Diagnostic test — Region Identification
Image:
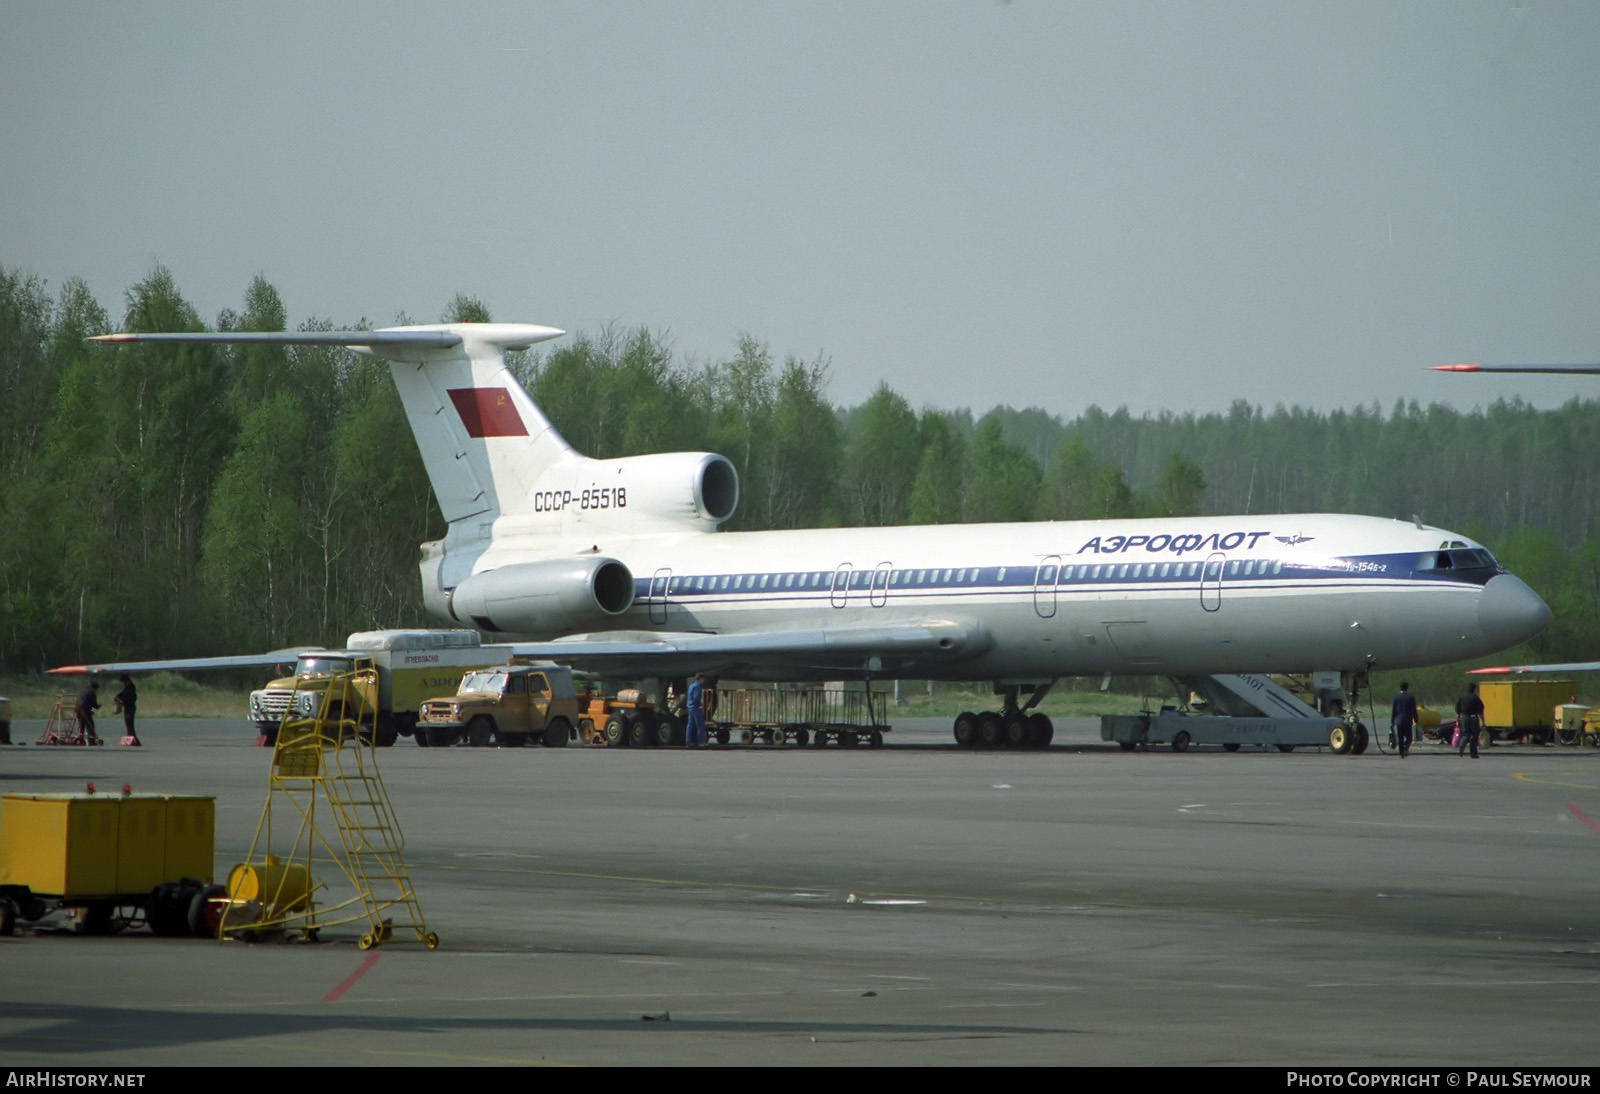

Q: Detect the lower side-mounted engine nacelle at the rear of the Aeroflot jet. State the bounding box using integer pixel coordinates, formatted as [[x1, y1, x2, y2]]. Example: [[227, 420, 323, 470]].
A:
[[445, 557, 634, 638]]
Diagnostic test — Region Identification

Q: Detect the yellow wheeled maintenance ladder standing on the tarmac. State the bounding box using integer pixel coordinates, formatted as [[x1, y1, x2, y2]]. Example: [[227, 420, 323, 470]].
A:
[[219, 669, 438, 950]]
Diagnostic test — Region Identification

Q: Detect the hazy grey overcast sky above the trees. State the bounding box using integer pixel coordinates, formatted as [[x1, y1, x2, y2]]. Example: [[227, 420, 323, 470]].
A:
[[0, 0, 1600, 417]]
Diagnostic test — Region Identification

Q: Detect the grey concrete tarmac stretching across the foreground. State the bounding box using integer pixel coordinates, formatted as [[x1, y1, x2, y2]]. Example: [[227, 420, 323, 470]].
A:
[[0, 720, 1600, 1068]]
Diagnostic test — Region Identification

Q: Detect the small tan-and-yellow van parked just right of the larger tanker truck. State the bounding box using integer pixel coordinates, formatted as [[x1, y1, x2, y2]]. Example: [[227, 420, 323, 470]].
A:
[[416, 664, 578, 749]]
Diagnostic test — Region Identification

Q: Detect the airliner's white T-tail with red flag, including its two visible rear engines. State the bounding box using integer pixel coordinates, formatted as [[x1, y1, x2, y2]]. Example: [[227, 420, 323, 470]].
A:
[[94, 323, 739, 632]]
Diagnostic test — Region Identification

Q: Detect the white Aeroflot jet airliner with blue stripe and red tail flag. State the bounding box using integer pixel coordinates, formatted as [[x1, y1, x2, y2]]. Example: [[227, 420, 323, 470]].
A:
[[59, 323, 1550, 742]]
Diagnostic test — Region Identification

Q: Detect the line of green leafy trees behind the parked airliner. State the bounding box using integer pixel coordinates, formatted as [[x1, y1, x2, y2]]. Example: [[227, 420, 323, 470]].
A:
[[0, 267, 1600, 672]]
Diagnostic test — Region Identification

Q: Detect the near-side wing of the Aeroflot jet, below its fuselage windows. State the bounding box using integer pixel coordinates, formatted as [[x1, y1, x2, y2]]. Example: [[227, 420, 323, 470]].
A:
[[510, 619, 990, 678]]
